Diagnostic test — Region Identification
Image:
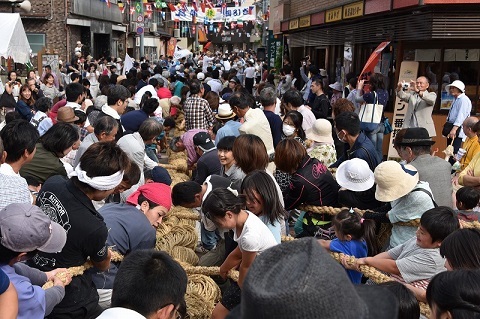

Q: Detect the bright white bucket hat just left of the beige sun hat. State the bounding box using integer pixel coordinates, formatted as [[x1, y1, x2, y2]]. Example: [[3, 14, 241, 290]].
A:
[[335, 158, 375, 192]]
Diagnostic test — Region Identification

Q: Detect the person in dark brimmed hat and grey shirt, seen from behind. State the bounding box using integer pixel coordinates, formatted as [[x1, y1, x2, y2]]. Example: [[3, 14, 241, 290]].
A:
[[394, 127, 452, 207]]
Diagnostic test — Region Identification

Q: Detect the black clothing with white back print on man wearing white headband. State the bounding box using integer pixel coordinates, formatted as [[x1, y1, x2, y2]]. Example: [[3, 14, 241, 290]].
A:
[[29, 175, 108, 317]]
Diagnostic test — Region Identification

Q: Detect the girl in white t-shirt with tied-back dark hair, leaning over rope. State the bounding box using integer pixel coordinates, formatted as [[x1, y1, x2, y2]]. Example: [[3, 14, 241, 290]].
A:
[[202, 188, 277, 319]]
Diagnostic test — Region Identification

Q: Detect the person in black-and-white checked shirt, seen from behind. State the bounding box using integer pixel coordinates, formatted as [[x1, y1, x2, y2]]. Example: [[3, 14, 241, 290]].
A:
[[183, 80, 215, 131]]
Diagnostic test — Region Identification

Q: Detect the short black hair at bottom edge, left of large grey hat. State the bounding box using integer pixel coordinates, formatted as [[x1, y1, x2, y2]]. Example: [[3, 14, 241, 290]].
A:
[[112, 249, 187, 317]]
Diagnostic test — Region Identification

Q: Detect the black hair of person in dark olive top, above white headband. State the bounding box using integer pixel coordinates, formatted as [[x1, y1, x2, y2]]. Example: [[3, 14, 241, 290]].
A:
[[40, 122, 80, 155]]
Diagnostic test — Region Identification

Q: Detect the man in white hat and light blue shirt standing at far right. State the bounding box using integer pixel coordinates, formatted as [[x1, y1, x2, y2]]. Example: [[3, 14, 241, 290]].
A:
[[442, 80, 472, 153]]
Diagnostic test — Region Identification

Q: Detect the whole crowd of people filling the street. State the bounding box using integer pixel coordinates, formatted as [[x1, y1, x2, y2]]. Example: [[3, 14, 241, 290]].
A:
[[0, 47, 480, 319]]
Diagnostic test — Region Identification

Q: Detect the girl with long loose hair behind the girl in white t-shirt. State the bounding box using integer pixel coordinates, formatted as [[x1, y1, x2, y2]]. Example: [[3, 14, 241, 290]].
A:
[[242, 171, 286, 244]]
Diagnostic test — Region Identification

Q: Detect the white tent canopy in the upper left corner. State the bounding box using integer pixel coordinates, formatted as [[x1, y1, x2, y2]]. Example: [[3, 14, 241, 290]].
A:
[[0, 13, 32, 63]]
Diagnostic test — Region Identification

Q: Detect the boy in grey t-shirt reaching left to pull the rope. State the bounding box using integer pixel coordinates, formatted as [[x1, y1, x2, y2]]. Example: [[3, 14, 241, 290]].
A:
[[344, 206, 460, 289]]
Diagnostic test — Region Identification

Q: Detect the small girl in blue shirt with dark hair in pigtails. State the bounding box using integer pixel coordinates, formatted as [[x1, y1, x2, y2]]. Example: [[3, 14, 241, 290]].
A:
[[319, 209, 378, 284]]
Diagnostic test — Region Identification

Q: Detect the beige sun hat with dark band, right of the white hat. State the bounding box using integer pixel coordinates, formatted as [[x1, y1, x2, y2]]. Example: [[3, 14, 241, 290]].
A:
[[374, 161, 419, 203]]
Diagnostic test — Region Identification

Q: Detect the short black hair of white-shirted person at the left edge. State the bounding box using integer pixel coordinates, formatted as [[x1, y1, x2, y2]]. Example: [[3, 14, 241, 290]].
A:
[[0, 120, 39, 163]]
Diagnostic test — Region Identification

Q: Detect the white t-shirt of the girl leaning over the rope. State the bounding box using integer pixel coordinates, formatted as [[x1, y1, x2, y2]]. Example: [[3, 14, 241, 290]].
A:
[[233, 210, 277, 254]]
